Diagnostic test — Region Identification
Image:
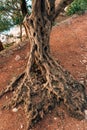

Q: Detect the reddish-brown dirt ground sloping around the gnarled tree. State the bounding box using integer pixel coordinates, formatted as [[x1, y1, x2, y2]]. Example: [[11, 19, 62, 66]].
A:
[[0, 14, 87, 130]]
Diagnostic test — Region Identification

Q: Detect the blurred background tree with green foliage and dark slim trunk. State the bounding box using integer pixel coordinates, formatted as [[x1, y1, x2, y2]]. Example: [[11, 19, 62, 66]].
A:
[[0, 0, 30, 39]]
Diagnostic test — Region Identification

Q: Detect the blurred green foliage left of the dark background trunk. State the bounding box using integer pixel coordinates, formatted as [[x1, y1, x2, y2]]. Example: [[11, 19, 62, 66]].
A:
[[0, 0, 22, 32]]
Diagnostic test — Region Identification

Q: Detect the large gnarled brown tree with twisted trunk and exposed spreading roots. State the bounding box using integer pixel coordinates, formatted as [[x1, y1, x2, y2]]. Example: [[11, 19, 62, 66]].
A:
[[0, 0, 87, 128]]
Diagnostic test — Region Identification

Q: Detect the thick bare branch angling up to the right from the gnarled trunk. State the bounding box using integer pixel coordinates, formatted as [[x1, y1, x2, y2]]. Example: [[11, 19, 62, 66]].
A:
[[54, 0, 73, 19]]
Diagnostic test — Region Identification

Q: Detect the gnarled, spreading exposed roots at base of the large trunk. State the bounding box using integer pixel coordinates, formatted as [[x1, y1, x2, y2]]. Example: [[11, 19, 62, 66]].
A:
[[0, 55, 87, 129]]
